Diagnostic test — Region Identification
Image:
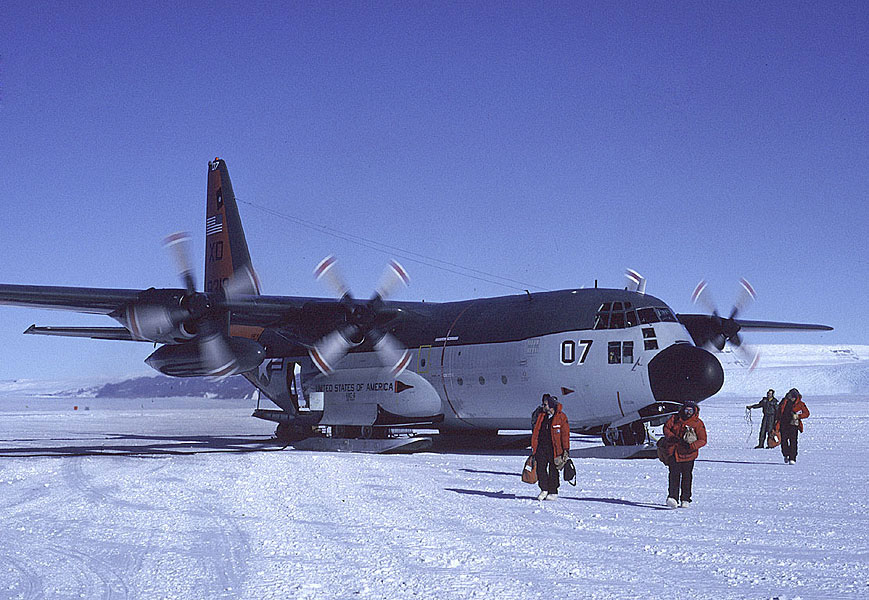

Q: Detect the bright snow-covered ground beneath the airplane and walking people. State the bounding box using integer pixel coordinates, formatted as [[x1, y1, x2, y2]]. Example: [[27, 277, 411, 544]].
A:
[[0, 392, 869, 600]]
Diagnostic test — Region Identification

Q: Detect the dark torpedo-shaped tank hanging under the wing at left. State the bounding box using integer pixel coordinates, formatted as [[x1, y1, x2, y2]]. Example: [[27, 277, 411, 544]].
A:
[[145, 337, 266, 377]]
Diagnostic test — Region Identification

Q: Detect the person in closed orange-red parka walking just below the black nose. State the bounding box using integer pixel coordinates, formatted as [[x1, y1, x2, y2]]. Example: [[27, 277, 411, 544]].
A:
[[664, 402, 706, 508]]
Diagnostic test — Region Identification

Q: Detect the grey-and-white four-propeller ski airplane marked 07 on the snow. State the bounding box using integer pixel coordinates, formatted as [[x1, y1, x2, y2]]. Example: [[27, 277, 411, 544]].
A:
[[0, 158, 832, 448]]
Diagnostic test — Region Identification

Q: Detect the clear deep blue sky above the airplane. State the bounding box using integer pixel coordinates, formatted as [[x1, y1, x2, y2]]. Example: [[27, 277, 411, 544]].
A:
[[0, 0, 869, 379]]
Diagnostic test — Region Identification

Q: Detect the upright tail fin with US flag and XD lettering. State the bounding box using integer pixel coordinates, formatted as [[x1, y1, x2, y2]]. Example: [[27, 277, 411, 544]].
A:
[[205, 158, 260, 295]]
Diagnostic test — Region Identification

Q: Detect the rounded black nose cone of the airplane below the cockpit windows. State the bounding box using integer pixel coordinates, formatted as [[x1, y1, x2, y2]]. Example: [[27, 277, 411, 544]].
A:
[[649, 344, 724, 402]]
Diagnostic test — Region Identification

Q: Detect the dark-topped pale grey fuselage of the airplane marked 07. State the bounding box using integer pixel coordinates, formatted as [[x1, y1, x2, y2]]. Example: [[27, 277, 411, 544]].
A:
[[241, 289, 723, 430]]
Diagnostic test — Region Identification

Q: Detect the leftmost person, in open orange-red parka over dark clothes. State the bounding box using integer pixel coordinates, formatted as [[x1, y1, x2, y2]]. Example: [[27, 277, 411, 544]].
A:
[[531, 396, 570, 500]]
